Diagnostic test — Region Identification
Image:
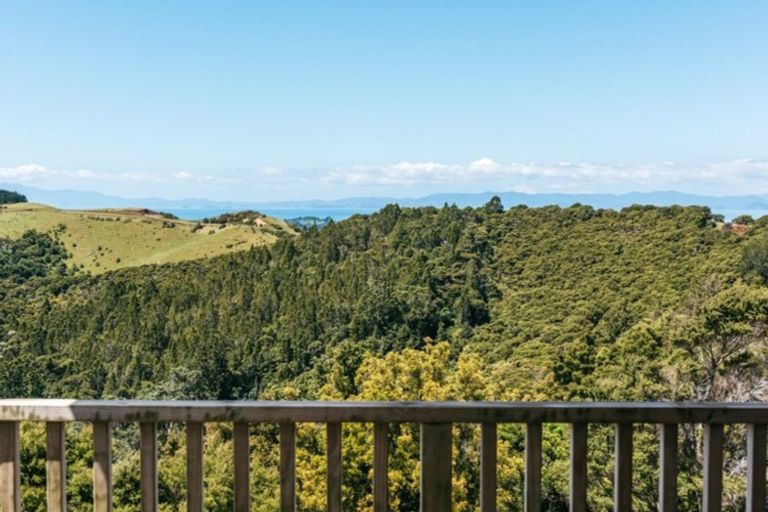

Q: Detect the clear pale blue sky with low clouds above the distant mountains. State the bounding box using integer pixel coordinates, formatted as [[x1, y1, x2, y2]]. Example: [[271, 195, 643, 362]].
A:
[[0, 0, 768, 200]]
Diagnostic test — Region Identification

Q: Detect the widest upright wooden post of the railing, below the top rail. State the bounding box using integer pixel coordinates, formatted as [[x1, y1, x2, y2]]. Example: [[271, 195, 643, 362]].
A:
[[421, 423, 452, 512]]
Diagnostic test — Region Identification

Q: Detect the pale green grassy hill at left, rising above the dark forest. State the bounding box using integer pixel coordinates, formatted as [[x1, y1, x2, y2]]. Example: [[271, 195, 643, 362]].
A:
[[0, 203, 294, 274]]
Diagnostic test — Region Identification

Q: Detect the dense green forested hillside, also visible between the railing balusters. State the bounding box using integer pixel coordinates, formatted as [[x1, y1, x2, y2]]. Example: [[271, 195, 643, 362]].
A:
[[0, 200, 768, 510]]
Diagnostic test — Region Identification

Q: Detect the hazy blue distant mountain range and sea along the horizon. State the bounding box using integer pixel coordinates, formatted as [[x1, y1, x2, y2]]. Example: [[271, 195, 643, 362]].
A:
[[0, 184, 768, 218]]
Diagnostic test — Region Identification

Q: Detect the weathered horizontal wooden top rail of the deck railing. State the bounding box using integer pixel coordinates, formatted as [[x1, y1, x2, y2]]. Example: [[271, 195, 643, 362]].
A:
[[0, 399, 768, 423]]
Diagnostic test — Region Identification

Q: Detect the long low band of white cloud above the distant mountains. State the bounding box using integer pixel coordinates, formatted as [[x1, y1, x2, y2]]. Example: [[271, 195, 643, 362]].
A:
[[0, 157, 768, 200]]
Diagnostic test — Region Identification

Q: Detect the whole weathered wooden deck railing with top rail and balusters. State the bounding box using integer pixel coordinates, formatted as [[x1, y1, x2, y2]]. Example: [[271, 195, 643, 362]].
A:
[[0, 400, 768, 512]]
